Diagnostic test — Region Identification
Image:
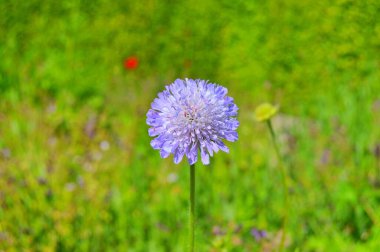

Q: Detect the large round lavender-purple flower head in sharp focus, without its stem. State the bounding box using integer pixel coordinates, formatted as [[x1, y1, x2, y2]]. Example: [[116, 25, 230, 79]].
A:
[[146, 79, 239, 164]]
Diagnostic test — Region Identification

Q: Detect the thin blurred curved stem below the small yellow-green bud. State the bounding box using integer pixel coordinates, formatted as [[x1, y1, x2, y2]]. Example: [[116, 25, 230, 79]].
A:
[[267, 120, 289, 251]]
